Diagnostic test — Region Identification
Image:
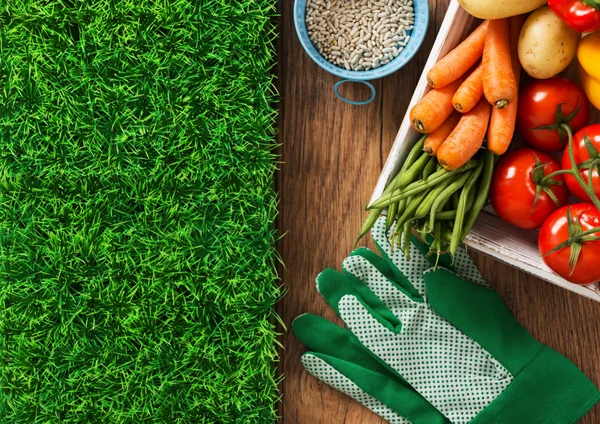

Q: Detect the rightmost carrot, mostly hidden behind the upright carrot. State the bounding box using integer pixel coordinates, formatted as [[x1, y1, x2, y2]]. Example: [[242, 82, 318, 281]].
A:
[[487, 15, 525, 155]]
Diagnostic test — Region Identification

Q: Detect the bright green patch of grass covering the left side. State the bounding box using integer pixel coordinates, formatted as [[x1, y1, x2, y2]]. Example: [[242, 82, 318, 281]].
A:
[[0, 0, 280, 424]]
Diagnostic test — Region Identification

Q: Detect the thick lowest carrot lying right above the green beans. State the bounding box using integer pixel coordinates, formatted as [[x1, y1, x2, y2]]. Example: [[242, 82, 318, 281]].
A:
[[437, 98, 492, 170]]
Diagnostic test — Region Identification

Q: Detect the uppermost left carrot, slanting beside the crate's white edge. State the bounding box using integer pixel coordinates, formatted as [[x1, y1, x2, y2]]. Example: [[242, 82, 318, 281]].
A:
[[427, 21, 488, 88]]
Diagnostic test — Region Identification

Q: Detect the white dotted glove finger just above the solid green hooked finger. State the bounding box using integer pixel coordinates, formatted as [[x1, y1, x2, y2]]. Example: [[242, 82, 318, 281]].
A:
[[342, 255, 423, 312]]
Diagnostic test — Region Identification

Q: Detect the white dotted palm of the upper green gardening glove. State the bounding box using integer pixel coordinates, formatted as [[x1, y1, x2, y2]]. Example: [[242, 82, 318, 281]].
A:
[[338, 294, 513, 424]]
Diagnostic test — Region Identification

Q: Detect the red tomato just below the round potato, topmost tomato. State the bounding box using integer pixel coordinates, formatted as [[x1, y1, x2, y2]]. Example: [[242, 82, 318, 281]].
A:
[[517, 77, 590, 152]]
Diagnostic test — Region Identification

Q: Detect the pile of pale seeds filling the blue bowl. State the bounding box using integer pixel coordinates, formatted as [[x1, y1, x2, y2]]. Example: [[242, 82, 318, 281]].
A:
[[306, 0, 415, 71]]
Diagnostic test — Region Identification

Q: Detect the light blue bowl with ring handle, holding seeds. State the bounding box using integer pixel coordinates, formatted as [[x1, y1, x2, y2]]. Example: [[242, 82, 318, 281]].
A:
[[294, 0, 429, 105]]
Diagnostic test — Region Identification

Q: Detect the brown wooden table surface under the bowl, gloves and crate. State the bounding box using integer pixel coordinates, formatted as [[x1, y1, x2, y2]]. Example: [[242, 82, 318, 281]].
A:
[[277, 0, 600, 424]]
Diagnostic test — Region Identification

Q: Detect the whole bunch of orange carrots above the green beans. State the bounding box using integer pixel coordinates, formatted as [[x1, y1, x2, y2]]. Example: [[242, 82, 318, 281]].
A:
[[410, 15, 525, 170]]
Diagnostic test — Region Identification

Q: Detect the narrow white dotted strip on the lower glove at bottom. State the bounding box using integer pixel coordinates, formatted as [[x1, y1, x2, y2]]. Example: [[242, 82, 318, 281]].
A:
[[302, 353, 411, 424]]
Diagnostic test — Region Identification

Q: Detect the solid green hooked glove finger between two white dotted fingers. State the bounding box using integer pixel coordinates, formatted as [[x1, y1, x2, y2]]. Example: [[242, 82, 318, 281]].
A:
[[317, 268, 406, 332]]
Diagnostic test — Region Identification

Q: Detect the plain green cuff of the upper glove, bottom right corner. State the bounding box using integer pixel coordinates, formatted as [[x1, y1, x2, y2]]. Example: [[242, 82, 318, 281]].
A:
[[470, 346, 600, 424]]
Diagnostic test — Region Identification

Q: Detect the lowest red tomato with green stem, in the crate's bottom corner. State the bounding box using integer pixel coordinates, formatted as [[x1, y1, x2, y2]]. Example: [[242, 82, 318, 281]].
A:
[[538, 203, 600, 284]]
